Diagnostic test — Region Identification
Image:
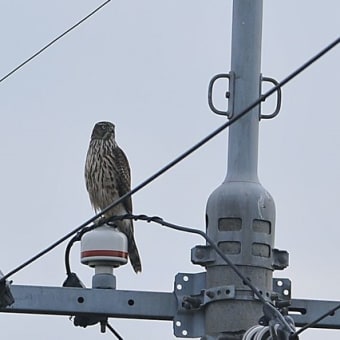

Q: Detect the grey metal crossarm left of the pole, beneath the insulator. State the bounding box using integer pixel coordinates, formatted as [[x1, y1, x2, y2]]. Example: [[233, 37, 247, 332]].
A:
[[0, 285, 177, 320]]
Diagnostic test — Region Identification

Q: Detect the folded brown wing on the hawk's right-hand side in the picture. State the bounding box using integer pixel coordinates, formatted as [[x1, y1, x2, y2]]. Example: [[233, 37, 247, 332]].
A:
[[113, 146, 132, 213]]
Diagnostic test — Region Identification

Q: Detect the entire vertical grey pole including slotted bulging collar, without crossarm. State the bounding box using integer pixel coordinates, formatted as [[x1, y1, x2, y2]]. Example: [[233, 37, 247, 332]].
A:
[[205, 0, 275, 340]]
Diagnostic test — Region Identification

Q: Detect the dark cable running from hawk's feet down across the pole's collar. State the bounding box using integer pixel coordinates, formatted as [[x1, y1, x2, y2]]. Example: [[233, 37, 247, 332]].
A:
[[110, 214, 295, 334]]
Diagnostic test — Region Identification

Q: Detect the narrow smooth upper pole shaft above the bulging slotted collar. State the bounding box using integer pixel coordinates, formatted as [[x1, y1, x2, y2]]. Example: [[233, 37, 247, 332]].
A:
[[227, 0, 262, 182]]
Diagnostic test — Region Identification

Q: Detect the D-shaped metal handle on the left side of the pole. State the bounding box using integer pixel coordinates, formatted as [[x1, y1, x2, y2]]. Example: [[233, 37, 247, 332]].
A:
[[208, 72, 235, 118]]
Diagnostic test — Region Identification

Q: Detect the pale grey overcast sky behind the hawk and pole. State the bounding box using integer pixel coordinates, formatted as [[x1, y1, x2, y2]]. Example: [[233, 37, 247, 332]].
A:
[[0, 0, 340, 340]]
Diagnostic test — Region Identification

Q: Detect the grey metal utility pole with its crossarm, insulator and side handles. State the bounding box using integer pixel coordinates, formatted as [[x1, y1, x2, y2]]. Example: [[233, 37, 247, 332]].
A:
[[0, 0, 340, 340]]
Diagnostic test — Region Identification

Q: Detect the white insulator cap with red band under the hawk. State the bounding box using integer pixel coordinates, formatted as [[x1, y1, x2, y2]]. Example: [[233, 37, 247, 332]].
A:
[[80, 225, 128, 267]]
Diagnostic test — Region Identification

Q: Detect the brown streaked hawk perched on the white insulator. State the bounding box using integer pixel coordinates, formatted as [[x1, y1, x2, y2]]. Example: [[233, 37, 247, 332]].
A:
[[85, 122, 142, 273]]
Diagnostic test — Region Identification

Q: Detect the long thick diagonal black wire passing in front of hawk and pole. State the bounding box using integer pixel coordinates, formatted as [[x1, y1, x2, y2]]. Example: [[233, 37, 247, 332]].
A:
[[0, 37, 340, 282]]
